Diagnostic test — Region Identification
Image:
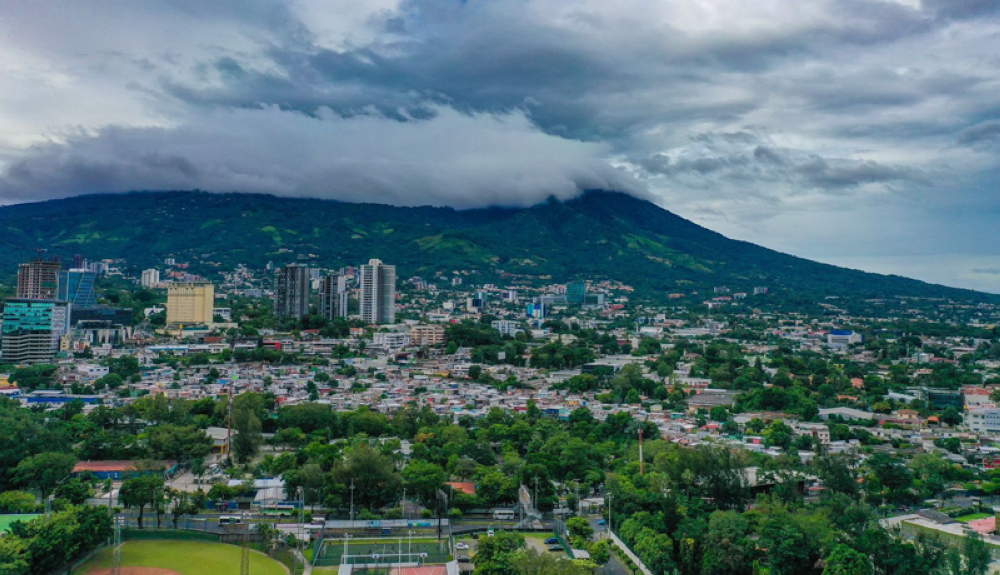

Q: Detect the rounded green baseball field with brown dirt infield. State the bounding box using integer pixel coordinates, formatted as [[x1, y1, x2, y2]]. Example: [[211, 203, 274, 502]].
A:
[[74, 540, 288, 575]]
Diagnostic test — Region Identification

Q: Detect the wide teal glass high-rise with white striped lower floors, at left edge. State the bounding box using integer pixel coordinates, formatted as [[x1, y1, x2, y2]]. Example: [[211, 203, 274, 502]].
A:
[[0, 298, 70, 365]]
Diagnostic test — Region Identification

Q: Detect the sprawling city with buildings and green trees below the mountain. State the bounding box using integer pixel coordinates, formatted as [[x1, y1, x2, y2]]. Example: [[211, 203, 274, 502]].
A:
[[0, 252, 1000, 575]]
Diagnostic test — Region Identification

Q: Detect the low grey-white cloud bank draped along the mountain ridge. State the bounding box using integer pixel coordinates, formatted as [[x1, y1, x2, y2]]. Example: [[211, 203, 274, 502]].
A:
[[0, 106, 634, 208]]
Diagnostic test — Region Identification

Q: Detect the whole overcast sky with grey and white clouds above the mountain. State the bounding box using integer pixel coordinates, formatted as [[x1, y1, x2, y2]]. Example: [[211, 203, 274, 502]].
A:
[[0, 0, 1000, 292]]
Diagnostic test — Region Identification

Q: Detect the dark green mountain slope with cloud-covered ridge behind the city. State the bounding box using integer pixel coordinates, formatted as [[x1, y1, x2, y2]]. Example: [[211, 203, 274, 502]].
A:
[[0, 191, 997, 301]]
